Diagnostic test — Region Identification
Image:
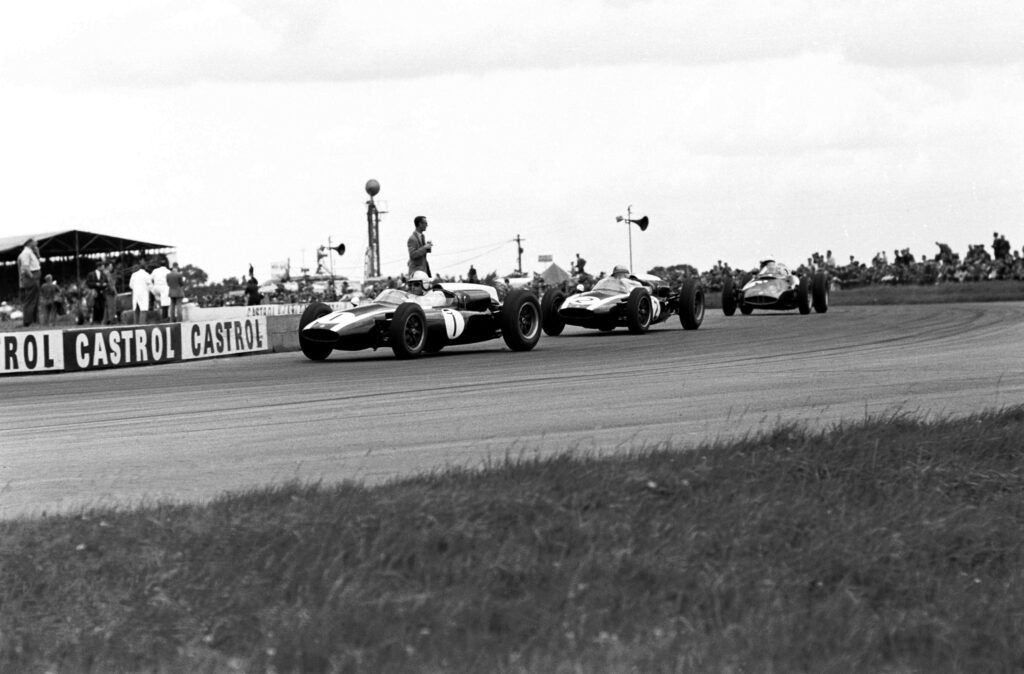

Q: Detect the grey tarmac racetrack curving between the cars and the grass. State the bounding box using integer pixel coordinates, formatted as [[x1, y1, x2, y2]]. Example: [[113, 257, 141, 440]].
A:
[[0, 302, 1024, 517]]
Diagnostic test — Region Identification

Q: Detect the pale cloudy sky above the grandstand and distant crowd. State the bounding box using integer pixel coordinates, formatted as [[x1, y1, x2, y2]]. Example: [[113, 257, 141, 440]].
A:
[[0, 0, 1024, 280]]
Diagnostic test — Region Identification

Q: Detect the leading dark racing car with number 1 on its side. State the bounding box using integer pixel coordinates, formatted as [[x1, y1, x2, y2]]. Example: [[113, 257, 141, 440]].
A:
[[299, 283, 541, 361]]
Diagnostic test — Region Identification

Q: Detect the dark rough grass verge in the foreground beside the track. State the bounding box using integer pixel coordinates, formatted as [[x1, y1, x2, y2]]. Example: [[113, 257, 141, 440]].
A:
[[0, 408, 1024, 672]]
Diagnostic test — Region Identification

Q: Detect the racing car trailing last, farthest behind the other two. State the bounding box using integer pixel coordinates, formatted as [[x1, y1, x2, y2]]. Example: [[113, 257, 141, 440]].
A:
[[722, 260, 828, 315]]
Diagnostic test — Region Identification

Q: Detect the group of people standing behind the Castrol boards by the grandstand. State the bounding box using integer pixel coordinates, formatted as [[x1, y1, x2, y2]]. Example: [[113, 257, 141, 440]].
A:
[[17, 239, 185, 327]]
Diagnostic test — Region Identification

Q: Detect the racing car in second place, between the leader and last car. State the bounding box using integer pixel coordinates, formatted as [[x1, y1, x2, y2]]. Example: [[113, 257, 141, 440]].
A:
[[541, 267, 705, 336]]
